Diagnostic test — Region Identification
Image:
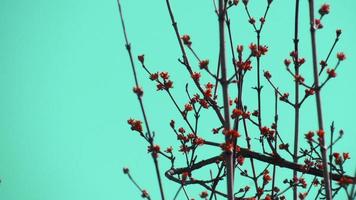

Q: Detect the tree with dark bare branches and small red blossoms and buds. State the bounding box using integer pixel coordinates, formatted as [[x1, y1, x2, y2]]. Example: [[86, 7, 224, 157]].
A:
[[118, 0, 356, 200]]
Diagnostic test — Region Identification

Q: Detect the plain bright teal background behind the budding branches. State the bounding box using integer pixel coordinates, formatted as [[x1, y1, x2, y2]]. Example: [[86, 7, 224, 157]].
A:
[[0, 0, 356, 200]]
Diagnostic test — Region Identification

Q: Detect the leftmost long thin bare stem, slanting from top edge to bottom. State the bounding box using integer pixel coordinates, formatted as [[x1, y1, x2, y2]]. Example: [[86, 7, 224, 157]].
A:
[[117, 0, 165, 200]]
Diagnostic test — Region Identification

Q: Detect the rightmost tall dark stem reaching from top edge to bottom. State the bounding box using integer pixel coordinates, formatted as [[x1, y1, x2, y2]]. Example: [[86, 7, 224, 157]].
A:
[[309, 0, 332, 200]]
